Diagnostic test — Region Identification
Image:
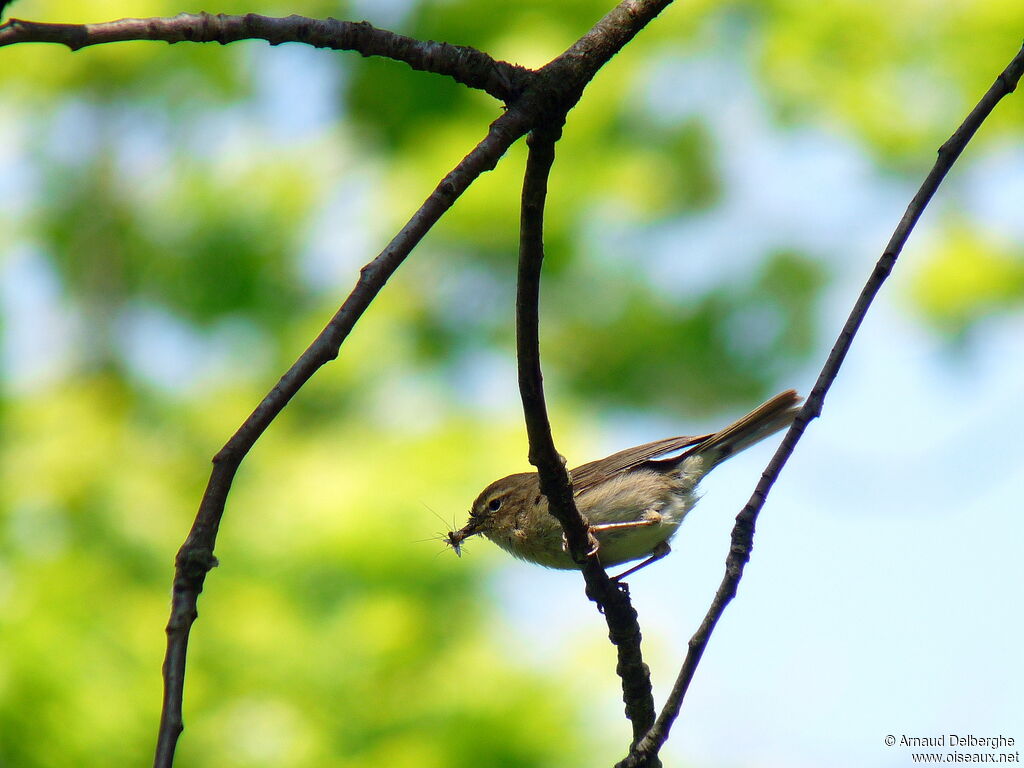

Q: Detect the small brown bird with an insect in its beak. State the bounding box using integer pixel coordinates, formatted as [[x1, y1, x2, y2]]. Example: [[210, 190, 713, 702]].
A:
[[446, 389, 801, 579]]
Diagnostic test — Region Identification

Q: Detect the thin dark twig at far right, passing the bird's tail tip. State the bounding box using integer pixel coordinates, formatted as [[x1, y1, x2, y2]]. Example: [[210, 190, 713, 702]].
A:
[[617, 40, 1024, 768]]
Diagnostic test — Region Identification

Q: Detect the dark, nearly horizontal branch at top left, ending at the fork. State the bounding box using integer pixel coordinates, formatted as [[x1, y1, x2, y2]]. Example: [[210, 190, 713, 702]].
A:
[[0, 12, 531, 101]]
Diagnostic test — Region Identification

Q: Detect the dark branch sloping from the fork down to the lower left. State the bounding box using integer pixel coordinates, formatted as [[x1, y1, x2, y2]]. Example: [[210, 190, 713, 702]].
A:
[[154, 110, 527, 768]]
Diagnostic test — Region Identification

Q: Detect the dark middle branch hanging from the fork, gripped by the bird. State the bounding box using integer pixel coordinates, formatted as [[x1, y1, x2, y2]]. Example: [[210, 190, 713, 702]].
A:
[[516, 120, 656, 760]]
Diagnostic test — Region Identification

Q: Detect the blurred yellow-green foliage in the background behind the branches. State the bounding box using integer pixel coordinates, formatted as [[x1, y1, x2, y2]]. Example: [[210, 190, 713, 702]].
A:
[[0, 0, 1024, 768]]
